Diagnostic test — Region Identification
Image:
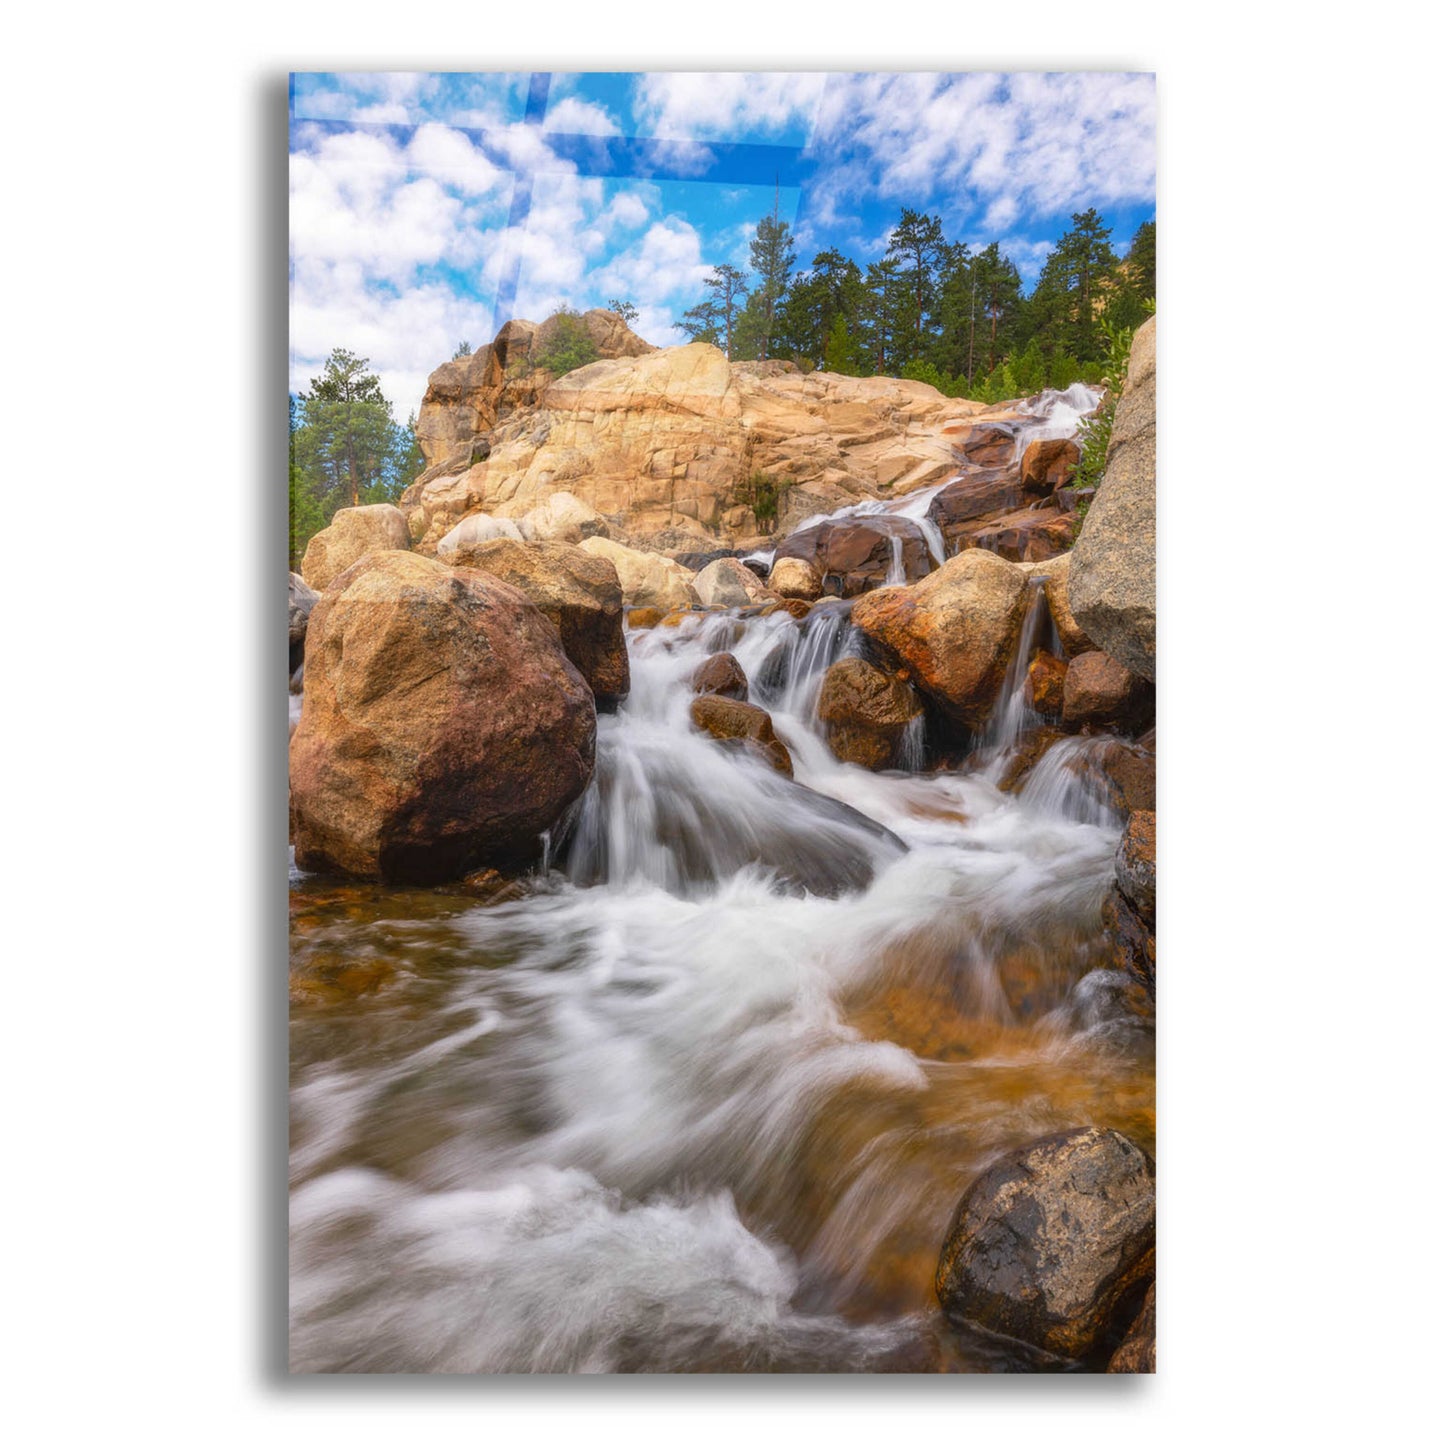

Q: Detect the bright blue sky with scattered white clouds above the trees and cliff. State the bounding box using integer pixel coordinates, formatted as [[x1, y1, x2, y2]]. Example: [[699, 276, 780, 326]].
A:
[[290, 71, 1155, 419]]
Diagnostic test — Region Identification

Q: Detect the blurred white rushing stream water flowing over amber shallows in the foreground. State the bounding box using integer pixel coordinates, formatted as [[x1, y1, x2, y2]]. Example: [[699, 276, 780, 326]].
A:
[[290, 603, 1153, 1371]]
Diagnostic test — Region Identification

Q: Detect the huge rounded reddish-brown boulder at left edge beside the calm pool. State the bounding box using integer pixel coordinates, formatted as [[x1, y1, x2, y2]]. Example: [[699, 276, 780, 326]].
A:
[[290, 552, 597, 883]]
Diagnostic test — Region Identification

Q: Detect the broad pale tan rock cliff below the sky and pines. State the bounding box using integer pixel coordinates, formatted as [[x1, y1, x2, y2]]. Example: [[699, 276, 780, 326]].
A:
[[400, 312, 985, 549]]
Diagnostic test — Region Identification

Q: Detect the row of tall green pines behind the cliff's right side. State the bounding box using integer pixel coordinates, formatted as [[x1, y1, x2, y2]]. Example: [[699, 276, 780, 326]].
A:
[[664, 207, 1155, 400]]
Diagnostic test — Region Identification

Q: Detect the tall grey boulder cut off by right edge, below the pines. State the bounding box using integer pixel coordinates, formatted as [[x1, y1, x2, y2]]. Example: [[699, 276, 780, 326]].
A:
[[1069, 316, 1156, 682]]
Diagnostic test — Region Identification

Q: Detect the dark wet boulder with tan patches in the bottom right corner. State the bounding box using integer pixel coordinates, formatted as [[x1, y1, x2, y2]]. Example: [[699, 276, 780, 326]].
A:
[[935, 1129, 1155, 1360]]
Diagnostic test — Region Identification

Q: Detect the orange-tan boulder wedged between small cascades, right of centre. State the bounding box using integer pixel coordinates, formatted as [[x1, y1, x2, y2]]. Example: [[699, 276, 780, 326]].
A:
[[853, 549, 1026, 728]]
